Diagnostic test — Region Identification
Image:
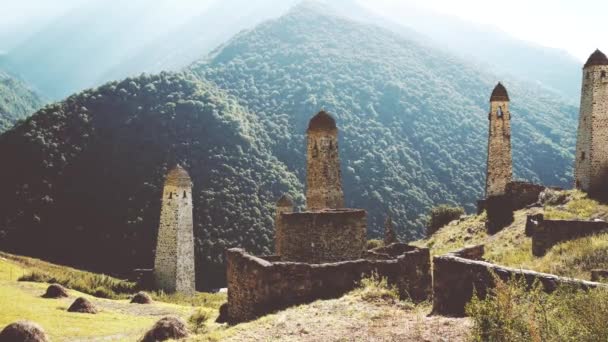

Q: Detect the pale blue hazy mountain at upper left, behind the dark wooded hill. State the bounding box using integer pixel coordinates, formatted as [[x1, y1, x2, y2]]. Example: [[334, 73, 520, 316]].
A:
[[0, 0, 296, 100]]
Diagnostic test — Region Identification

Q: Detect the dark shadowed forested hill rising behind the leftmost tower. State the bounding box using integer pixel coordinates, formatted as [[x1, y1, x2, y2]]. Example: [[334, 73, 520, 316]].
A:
[[0, 73, 302, 286]]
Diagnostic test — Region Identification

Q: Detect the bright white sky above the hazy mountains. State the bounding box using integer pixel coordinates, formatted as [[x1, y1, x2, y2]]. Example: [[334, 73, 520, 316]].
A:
[[0, 0, 608, 61]]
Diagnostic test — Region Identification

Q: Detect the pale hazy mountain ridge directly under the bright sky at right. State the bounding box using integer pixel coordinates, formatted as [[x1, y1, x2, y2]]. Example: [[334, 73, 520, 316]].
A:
[[354, 0, 580, 105]]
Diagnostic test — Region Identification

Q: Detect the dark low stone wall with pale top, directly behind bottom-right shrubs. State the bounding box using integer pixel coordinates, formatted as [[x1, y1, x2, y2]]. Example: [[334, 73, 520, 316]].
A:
[[433, 247, 604, 317]]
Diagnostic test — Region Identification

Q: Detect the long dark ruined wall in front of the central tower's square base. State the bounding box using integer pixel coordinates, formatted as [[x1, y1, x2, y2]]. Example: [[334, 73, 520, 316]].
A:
[[226, 244, 431, 324]]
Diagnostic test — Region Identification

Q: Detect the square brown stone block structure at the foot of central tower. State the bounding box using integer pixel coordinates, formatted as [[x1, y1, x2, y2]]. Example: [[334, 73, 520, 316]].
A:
[[279, 209, 367, 264]]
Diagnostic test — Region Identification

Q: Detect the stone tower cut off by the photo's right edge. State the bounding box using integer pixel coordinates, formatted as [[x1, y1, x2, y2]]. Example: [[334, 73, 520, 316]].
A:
[[574, 50, 608, 196]]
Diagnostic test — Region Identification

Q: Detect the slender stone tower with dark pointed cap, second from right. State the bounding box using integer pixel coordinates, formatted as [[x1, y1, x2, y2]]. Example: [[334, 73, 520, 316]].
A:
[[486, 82, 513, 198]]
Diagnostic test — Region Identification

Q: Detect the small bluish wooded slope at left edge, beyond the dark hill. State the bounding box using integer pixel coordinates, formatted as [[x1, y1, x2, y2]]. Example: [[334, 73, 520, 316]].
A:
[[0, 70, 44, 133]]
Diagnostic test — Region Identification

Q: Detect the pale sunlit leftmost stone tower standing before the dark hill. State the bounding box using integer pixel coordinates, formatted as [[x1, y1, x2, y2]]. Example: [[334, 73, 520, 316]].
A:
[[154, 165, 195, 293]]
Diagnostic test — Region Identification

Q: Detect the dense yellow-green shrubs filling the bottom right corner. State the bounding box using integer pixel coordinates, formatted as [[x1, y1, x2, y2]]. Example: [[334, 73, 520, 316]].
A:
[[466, 279, 608, 342]]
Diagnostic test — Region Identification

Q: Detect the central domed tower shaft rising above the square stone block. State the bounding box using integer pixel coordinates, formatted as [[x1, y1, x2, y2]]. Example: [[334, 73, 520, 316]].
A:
[[306, 111, 344, 210]]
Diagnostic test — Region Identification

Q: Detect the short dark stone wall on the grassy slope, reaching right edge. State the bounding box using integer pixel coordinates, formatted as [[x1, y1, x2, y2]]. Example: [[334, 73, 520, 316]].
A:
[[526, 215, 608, 256]]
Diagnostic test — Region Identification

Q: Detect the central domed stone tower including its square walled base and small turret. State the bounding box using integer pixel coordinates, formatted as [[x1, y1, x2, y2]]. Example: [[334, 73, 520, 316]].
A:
[[275, 111, 367, 264]]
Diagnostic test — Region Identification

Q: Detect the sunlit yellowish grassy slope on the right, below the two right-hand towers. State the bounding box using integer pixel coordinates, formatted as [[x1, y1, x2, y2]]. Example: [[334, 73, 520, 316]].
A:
[[416, 191, 608, 280]]
